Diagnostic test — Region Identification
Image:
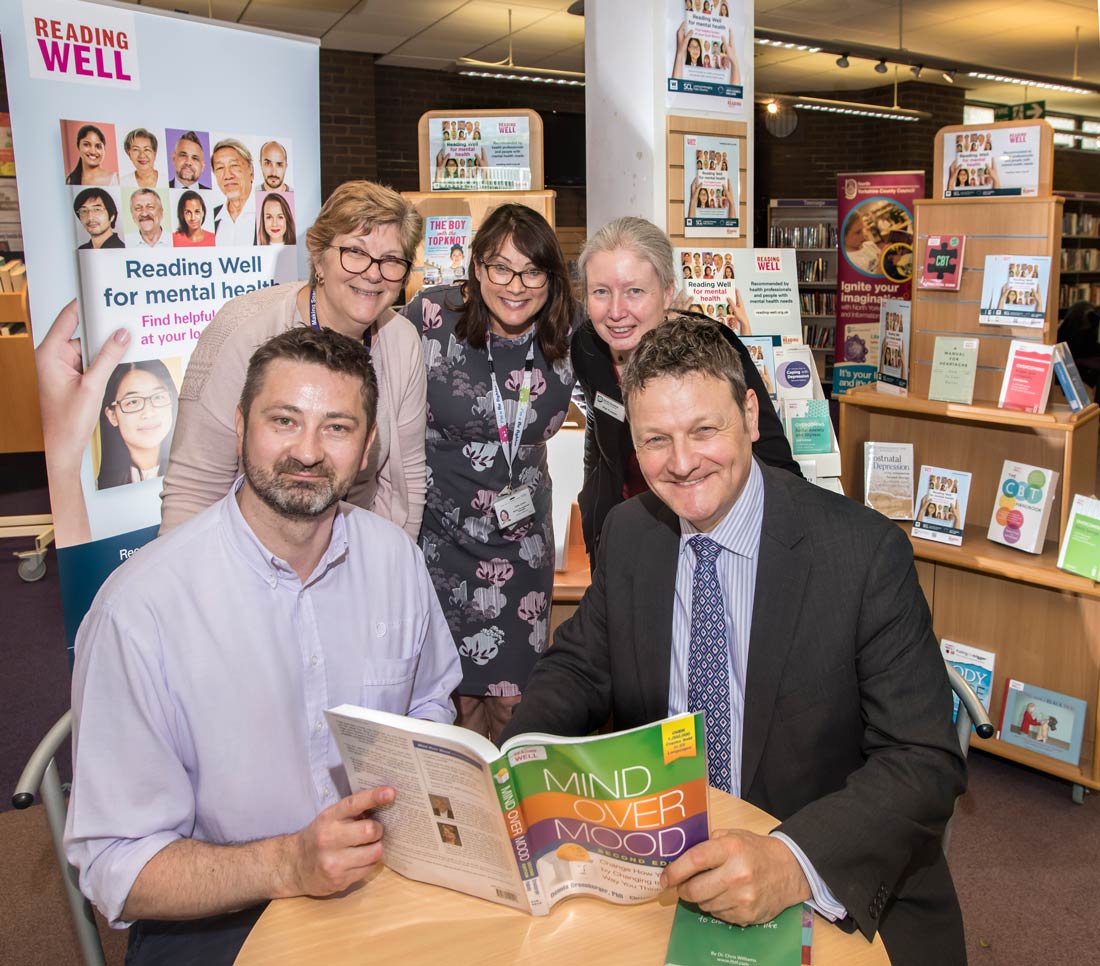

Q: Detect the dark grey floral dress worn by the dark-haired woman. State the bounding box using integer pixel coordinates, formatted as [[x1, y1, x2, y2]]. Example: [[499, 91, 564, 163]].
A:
[[405, 285, 573, 696]]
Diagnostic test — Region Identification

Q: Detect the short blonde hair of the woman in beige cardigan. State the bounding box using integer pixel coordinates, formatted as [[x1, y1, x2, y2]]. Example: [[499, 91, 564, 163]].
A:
[[306, 182, 424, 285]]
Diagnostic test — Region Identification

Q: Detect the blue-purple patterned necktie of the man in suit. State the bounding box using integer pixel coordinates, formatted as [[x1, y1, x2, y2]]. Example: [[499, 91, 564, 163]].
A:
[[688, 535, 732, 791]]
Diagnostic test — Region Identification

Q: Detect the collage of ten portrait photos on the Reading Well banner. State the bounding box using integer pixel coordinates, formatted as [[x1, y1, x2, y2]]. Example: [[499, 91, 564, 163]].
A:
[[61, 119, 298, 251]]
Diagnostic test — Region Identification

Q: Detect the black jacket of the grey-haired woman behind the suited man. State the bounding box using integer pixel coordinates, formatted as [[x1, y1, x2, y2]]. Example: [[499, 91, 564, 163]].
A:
[[570, 319, 802, 563]]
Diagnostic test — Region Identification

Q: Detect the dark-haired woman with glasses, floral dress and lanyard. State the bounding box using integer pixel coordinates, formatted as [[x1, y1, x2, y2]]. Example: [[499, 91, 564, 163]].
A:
[[405, 205, 575, 739]]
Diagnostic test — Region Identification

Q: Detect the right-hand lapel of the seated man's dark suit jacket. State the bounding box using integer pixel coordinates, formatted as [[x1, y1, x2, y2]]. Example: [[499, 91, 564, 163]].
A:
[[739, 466, 810, 795]]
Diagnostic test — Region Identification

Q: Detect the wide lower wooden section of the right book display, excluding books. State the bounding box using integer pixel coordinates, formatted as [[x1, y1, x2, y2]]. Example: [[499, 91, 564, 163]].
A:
[[839, 386, 1100, 791]]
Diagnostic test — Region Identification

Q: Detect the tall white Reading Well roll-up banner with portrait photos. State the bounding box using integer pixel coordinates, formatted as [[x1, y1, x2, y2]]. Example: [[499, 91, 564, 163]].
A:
[[0, 0, 320, 648]]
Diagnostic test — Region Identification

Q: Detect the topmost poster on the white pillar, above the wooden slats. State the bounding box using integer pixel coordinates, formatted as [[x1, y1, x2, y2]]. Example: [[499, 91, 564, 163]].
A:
[[664, 0, 752, 113]]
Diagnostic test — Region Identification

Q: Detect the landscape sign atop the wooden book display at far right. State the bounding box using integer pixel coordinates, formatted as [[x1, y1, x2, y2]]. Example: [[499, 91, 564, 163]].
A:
[[941, 127, 1041, 198]]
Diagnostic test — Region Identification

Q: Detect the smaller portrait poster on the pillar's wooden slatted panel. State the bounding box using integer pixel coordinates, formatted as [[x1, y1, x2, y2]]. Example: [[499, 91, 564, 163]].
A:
[[684, 134, 741, 238]]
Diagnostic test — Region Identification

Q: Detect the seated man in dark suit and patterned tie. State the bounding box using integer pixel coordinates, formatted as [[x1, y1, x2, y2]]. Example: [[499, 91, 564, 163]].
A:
[[502, 318, 966, 966]]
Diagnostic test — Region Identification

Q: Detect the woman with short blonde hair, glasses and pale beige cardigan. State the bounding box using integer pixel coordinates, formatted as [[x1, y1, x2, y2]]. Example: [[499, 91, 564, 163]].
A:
[[161, 182, 426, 539]]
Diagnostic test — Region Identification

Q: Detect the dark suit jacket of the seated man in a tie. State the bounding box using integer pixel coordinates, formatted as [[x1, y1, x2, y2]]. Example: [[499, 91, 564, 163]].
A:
[[502, 466, 966, 966]]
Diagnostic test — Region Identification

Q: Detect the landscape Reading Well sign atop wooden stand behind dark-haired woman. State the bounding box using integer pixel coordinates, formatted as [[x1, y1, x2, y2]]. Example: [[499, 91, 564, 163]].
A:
[[428, 117, 531, 191]]
